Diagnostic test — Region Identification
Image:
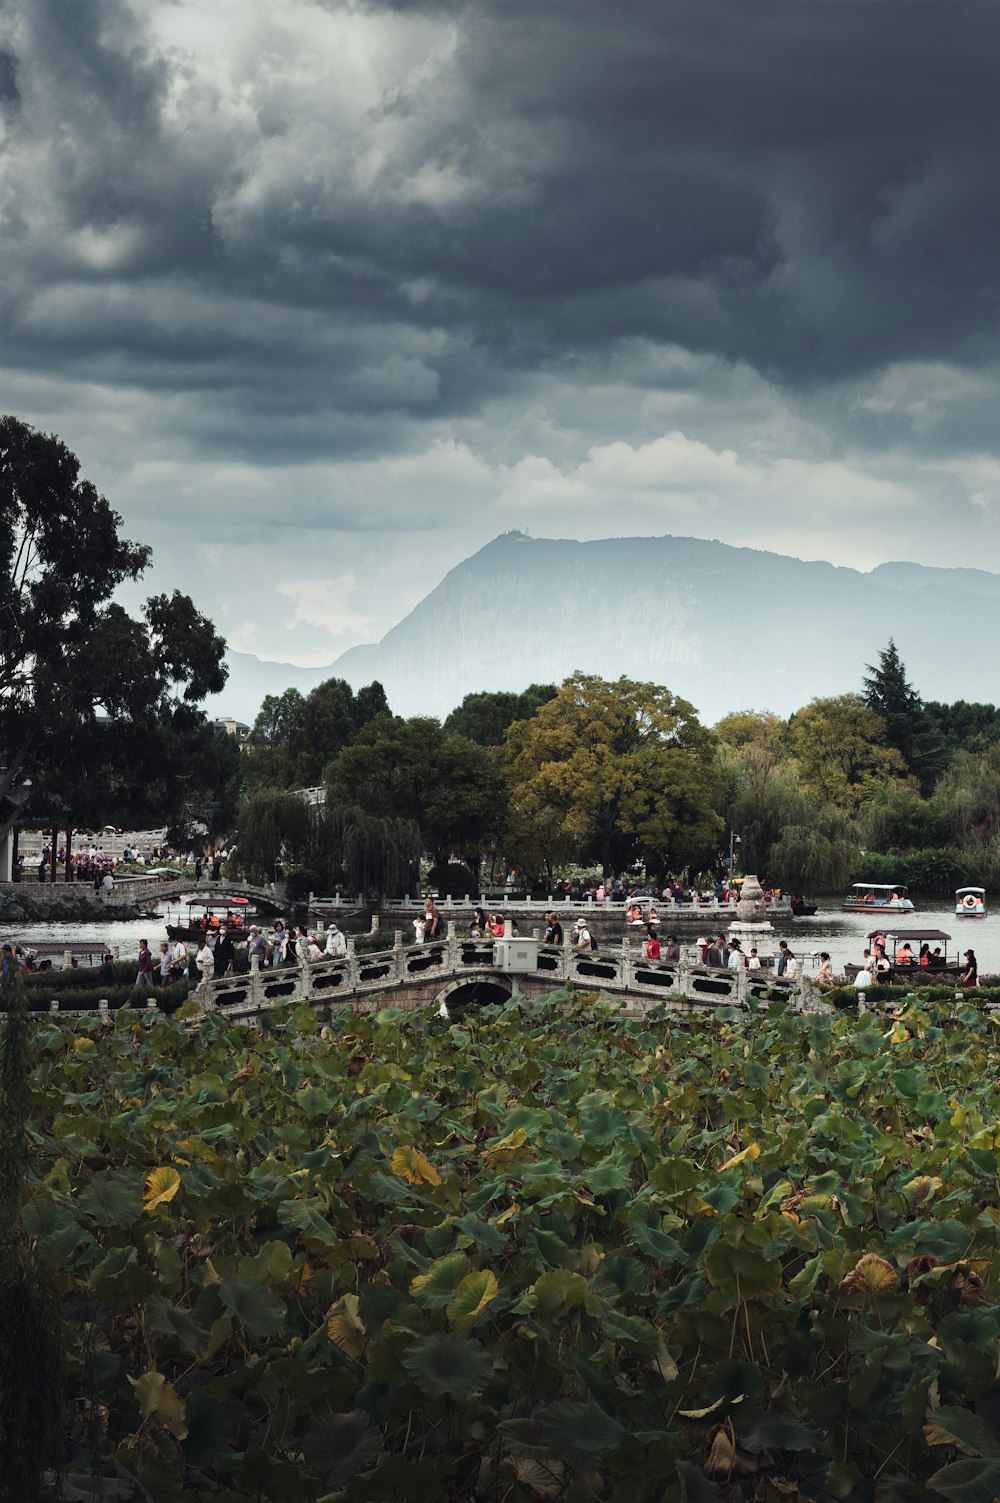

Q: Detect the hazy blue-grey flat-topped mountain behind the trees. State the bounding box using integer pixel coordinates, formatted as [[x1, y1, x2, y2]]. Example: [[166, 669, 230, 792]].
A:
[[206, 532, 1000, 723]]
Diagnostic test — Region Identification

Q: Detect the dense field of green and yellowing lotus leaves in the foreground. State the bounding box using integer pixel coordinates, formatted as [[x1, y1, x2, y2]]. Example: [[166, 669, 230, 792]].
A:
[[15, 996, 1000, 1503]]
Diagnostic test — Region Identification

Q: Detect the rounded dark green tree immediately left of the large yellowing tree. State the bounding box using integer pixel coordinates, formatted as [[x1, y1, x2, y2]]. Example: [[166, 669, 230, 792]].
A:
[[328, 714, 502, 870]]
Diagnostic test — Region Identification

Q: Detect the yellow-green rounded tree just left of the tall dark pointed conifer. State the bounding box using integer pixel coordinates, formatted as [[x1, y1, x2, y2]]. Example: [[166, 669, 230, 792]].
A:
[[788, 694, 907, 812]]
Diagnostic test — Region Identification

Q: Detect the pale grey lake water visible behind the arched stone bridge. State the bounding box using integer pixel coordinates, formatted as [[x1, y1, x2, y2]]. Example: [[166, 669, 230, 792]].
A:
[[3, 899, 1000, 975]]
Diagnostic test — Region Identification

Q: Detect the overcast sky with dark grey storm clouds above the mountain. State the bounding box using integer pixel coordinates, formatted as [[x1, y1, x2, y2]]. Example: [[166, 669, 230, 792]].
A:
[[0, 0, 1000, 663]]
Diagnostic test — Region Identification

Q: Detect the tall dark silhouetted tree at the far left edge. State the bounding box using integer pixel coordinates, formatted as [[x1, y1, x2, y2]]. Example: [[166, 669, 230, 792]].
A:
[[0, 418, 226, 859]]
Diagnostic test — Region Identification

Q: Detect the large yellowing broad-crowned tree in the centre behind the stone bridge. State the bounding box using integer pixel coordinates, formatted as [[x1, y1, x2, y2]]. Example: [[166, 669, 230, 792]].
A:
[[502, 673, 722, 875]]
